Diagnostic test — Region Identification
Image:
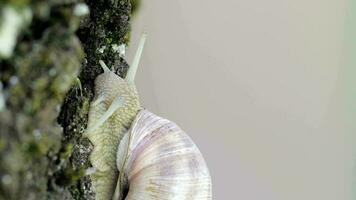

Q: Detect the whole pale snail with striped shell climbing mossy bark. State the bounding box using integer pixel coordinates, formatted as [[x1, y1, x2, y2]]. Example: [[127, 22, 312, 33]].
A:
[[84, 34, 212, 200]]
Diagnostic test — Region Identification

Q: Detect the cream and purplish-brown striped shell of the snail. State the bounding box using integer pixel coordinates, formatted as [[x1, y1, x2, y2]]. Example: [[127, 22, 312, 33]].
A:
[[116, 109, 212, 200]]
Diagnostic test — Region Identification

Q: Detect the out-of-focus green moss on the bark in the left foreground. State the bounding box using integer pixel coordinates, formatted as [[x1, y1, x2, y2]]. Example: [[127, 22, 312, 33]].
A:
[[0, 1, 84, 199]]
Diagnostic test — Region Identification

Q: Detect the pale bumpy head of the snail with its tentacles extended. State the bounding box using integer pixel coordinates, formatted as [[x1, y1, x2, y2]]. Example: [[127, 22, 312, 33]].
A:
[[91, 34, 146, 129]]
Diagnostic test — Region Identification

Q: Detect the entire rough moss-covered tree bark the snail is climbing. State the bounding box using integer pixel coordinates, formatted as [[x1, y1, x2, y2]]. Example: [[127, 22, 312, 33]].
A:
[[0, 0, 136, 200]]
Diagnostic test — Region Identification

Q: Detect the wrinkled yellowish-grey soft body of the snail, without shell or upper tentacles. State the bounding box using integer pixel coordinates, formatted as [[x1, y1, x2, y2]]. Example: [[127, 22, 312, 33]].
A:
[[84, 71, 140, 200]]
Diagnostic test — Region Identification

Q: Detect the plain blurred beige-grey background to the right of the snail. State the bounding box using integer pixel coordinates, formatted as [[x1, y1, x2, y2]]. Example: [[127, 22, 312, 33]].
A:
[[128, 0, 356, 200]]
